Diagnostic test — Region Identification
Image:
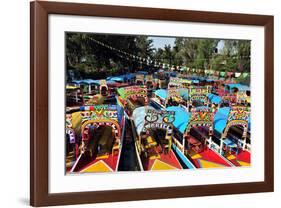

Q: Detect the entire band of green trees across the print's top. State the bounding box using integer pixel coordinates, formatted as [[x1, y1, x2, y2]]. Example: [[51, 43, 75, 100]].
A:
[[66, 33, 250, 78]]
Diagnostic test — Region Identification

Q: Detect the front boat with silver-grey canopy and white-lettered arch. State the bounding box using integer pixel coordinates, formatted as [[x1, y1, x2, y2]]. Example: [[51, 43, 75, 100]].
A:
[[132, 106, 182, 170]]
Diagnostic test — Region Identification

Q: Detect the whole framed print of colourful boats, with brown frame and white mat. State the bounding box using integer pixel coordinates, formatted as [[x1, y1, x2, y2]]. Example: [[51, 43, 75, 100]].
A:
[[30, 1, 274, 206]]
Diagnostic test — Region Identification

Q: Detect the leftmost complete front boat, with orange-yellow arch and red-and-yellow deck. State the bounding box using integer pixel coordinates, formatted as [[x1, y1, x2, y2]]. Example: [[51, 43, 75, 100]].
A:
[[70, 105, 125, 172]]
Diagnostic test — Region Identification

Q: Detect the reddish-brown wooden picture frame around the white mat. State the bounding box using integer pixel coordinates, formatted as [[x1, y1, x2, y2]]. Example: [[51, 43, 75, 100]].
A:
[[30, 1, 274, 206]]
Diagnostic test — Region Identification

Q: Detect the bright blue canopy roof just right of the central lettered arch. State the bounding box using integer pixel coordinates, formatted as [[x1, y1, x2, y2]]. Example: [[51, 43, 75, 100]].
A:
[[166, 106, 191, 134]]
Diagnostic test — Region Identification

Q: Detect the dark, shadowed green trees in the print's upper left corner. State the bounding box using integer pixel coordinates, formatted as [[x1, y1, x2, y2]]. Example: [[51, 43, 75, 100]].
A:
[[66, 33, 154, 78]]
